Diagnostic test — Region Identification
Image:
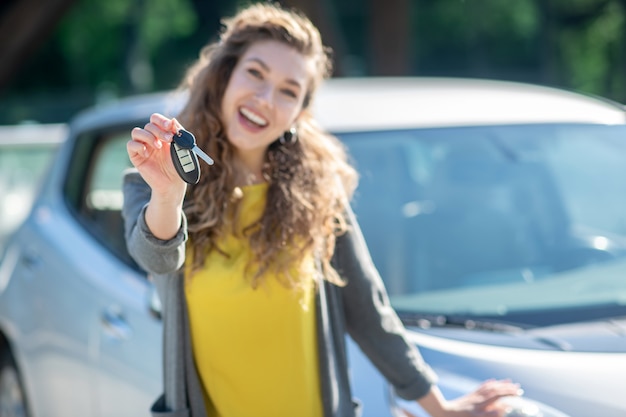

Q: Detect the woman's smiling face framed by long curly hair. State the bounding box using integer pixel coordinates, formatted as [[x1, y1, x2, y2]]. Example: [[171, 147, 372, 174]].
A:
[[222, 40, 312, 168]]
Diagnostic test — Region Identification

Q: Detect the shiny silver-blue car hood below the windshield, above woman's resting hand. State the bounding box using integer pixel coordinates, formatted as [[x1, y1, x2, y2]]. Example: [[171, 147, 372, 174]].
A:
[[400, 318, 626, 417]]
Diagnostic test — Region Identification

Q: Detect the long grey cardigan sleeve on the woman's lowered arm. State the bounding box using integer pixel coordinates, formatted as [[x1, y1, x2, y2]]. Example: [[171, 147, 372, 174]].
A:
[[333, 202, 436, 400]]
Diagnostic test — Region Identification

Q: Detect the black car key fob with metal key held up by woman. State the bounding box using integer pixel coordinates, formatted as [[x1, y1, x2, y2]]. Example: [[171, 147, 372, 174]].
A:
[[170, 129, 213, 184]]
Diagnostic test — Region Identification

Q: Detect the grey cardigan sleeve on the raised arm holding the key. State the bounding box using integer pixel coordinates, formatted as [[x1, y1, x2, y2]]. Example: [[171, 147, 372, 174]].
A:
[[122, 169, 187, 274]]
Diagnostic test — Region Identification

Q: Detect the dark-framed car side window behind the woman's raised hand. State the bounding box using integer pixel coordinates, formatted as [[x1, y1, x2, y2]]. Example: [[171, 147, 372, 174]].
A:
[[65, 127, 139, 270]]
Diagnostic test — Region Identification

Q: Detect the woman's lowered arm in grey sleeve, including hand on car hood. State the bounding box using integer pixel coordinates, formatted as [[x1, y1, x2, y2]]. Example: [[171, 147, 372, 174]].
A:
[[333, 203, 521, 417]]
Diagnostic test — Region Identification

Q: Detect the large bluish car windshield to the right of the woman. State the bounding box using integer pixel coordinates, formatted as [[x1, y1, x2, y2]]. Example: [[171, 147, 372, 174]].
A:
[[340, 124, 626, 325]]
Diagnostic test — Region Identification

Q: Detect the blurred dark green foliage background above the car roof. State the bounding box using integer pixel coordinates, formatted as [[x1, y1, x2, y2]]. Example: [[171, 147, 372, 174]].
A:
[[0, 0, 626, 124]]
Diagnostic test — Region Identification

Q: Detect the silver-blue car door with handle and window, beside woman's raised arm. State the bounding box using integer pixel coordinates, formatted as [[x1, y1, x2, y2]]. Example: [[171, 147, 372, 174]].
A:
[[66, 126, 162, 417]]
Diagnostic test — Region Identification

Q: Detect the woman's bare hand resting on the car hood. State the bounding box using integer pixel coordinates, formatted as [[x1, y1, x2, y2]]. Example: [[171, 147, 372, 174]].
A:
[[419, 380, 523, 417]]
